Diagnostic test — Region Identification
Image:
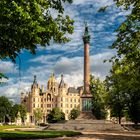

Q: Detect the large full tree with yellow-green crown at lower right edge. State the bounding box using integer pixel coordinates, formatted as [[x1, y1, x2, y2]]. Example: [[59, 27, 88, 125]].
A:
[[107, 58, 140, 123]]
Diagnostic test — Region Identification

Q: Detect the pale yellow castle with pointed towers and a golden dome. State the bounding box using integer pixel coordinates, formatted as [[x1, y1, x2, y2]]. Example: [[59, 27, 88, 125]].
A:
[[21, 74, 83, 123]]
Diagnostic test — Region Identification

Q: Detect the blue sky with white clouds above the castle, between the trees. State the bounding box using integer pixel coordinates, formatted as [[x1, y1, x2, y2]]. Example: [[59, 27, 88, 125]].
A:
[[0, 0, 130, 103]]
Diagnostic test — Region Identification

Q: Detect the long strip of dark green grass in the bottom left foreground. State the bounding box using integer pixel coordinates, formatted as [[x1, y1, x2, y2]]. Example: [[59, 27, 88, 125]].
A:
[[0, 131, 81, 139]]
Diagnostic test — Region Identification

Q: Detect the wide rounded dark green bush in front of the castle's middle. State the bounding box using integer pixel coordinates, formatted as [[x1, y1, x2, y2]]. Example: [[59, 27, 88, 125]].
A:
[[47, 108, 65, 123]]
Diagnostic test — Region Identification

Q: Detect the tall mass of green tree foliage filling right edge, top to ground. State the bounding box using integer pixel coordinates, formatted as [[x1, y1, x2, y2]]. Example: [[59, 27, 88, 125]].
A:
[[99, 0, 140, 123]]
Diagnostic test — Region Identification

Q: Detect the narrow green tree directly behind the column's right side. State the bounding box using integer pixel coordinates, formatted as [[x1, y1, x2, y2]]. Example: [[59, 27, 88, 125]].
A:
[[90, 75, 107, 119]]
